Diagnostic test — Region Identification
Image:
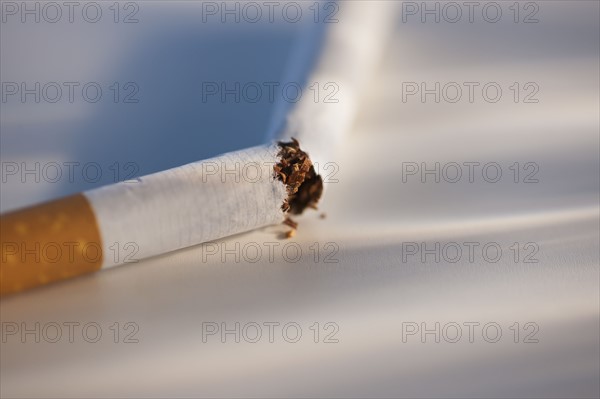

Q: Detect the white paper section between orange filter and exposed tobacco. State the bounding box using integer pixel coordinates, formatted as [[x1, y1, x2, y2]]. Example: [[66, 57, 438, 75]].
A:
[[84, 145, 288, 268]]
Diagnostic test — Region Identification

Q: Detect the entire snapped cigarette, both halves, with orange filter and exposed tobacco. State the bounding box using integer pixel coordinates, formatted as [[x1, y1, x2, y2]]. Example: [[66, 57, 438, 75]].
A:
[[0, 2, 393, 295]]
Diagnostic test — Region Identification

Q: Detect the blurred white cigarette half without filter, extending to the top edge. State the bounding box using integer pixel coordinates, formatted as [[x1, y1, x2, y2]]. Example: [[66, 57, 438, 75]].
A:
[[279, 0, 398, 166]]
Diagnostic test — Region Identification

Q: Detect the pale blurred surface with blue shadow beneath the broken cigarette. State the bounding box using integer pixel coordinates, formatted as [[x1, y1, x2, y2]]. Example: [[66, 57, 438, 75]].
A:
[[0, 1, 600, 397]]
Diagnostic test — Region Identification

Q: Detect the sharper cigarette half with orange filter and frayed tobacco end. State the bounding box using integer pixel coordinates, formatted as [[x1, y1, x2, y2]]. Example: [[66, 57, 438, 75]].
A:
[[0, 141, 323, 295]]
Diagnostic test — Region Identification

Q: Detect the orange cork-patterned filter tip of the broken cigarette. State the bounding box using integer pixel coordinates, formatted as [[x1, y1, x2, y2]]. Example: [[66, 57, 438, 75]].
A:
[[0, 194, 102, 295]]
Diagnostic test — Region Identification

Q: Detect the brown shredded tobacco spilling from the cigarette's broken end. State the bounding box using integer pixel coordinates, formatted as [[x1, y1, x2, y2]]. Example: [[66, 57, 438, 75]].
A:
[[273, 138, 323, 217]]
